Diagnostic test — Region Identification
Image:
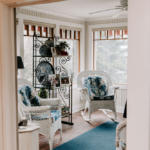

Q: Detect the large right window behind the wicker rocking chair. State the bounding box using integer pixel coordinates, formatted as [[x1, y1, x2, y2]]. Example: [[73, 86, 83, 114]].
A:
[[93, 30, 128, 84]]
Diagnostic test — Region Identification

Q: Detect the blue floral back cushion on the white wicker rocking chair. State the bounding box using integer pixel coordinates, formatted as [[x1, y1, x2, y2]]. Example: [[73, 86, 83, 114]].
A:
[[83, 77, 107, 97]]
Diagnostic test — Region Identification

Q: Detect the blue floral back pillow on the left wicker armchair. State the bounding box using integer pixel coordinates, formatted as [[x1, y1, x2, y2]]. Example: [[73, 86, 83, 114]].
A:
[[18, 85, 40, 107]]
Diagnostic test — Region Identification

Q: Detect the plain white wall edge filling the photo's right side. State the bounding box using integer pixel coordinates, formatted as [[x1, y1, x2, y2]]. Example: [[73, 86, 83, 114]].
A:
[[127, 0, 150, 150]]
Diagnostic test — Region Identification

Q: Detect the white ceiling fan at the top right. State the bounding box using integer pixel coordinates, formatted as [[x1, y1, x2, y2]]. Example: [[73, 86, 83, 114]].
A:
[[89, 0, 128, 18]]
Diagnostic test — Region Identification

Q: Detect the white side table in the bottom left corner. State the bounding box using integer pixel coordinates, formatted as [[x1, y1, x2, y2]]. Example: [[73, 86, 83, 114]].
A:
[[18, 124, 40, 150]]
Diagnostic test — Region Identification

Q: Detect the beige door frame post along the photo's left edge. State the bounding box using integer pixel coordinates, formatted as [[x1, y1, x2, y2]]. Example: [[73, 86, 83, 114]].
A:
[[0, 3, 18, 150]]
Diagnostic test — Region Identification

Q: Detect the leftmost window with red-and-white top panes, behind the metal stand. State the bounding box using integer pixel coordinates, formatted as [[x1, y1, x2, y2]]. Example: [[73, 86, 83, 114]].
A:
[[24, 25, 53, 83]]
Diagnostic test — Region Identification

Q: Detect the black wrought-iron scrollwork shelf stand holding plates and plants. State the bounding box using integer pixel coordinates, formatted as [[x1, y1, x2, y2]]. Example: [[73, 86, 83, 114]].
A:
[[32, 35, 74, 125]]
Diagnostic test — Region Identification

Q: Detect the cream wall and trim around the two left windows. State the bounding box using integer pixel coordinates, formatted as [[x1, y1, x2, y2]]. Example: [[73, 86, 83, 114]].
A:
[[17, 8, 85, 112]]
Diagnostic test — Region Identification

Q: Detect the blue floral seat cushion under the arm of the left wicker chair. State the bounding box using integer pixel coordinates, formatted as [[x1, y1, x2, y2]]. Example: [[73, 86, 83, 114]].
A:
[[31, 110, 61, 122]]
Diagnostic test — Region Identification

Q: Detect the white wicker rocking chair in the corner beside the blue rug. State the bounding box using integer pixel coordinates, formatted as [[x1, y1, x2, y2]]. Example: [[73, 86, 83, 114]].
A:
[[77, 70, 119, 121]]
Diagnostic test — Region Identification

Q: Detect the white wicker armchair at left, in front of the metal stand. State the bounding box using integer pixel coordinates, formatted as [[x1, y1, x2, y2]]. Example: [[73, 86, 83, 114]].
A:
[[18, 78, 62, 150]]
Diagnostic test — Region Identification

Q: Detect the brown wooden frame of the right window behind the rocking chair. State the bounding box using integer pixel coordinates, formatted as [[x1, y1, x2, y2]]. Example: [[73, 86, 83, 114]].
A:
[[93, 29, 128, 85]]
